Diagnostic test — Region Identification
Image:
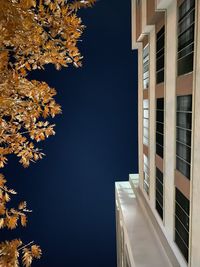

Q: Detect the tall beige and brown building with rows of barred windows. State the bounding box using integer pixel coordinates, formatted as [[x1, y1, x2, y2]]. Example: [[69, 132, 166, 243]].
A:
[[115, 0, 200, 267]]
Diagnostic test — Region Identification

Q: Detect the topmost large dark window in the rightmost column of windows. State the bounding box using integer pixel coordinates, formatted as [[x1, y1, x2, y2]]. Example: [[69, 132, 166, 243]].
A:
[[178, 0, 195, 75]]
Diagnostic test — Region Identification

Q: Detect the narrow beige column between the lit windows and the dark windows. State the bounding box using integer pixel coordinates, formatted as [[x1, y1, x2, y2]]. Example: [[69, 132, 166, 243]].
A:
[[149, 27, 156, 209]]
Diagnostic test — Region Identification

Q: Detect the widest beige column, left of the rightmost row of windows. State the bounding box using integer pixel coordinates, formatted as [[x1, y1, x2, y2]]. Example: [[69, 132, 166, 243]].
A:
[[164, 1, 177, 240]]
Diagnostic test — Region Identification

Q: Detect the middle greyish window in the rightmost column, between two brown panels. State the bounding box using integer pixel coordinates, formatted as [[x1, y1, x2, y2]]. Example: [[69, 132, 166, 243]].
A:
[[176, 95, 192, 179]]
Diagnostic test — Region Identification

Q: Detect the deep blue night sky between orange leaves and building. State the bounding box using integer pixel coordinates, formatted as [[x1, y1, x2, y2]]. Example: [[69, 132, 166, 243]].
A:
[[1, 0, 138, 267]]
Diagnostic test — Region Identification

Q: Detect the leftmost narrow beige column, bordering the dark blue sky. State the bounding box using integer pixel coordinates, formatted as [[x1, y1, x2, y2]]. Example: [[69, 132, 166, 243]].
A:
[[138, 43, 143, 191]]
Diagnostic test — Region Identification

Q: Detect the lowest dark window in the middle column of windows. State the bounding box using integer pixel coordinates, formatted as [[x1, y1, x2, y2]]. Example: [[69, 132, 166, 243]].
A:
[[156, 168, 163, 219]]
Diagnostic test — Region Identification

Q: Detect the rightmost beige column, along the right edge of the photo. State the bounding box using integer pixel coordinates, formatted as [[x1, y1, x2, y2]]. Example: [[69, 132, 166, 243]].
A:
[[190, 0, 200, 267]]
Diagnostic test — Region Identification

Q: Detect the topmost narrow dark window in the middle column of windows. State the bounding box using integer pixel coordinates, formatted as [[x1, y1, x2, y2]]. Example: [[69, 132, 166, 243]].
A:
[[156, 26, 165, 84]]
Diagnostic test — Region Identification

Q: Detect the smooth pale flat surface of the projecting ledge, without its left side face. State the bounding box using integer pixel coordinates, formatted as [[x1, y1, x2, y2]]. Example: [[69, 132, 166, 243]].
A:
[[115, 182, 179, 267]]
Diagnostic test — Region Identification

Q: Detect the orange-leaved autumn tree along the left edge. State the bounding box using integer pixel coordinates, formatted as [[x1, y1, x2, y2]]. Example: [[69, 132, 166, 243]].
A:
[[0, 0, 95, 266]]
